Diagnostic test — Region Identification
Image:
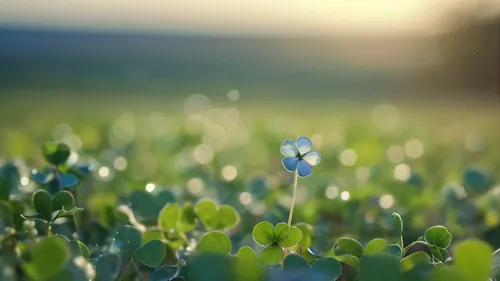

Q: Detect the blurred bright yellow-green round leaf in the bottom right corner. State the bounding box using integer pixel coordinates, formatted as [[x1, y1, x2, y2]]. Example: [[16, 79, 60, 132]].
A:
[[453, 239, 493, 281]]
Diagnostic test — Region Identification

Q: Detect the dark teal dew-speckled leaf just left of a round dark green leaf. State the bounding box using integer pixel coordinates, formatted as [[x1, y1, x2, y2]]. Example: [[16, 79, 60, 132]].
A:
[[111, 225, 141, 260]]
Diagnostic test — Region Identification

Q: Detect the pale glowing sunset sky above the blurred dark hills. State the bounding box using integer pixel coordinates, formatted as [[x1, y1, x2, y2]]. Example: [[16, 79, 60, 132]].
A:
[[0, 0, 500, 34]]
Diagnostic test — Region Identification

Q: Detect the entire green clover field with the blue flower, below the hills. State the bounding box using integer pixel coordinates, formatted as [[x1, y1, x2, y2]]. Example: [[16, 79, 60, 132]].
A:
[[0, 100, 500, 281]]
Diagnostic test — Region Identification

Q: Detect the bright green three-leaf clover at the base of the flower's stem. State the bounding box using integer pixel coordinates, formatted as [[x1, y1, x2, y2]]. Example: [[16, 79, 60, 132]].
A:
[[252, 221, 302, 265]]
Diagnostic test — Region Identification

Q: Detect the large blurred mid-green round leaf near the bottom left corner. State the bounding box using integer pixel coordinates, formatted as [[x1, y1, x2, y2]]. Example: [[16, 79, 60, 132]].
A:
[[24, 238, 69, 281]]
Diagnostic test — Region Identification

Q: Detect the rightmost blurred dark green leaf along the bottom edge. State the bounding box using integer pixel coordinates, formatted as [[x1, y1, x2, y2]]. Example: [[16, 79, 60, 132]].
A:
[[359, 253, 401, 281]]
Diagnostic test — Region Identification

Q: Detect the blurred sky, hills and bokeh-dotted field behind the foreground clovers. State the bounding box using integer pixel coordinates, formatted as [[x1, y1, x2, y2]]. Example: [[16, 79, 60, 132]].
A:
[[0, 0, 500, 246]]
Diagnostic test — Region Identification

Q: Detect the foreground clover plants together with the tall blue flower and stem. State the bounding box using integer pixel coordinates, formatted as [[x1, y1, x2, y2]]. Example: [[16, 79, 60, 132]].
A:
[[0, 137, 500, 281]]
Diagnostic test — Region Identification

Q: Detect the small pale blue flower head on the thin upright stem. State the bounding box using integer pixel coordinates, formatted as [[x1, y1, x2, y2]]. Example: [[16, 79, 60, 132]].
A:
[[280, 137, 321, 178]]
